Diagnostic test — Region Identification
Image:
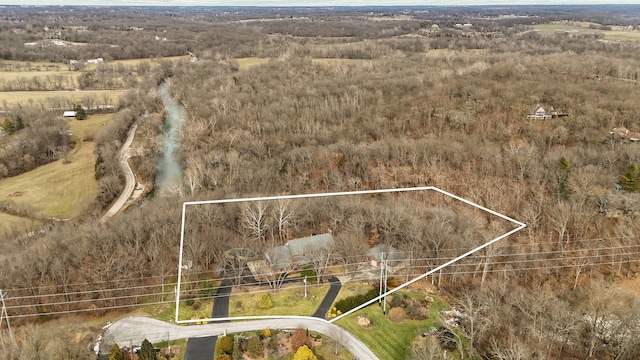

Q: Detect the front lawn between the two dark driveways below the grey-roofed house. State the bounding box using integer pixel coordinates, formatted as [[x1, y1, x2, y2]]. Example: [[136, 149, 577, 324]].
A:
[[229, 283, 329, 317]]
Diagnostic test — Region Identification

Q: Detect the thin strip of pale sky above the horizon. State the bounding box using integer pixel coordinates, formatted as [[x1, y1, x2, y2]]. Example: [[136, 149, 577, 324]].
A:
[[0, 0, 640, 6]]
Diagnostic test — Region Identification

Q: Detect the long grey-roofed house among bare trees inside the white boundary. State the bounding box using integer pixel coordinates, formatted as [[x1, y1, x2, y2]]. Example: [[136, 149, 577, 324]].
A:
[[265, 233, 334, 270]]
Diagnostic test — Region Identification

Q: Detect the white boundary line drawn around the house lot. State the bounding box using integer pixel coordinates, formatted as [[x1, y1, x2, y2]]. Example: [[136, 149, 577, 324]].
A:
[[176, 186, 527, 324]]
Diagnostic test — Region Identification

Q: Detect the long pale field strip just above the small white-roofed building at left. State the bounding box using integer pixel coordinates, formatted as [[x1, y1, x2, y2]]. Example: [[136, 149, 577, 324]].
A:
[[0, 90, 125, 110]]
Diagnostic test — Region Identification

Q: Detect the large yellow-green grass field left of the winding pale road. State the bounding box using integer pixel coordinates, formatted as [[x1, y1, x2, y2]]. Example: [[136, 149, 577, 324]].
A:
[[0, 115, 113, 221]]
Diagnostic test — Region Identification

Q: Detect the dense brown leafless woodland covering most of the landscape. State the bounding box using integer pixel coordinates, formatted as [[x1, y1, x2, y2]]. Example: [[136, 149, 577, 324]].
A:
[[0, 7, 640, 359]]
